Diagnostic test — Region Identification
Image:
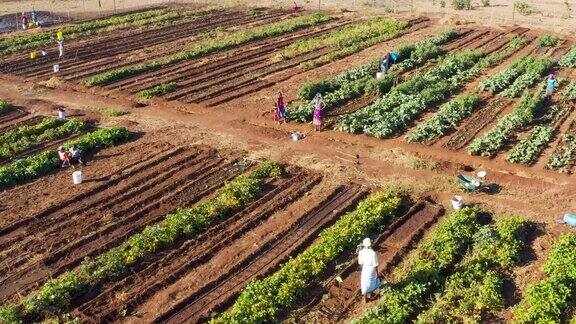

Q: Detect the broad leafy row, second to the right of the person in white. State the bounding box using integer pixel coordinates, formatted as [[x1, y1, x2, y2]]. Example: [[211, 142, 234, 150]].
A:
[[415, 217, 527, 323]]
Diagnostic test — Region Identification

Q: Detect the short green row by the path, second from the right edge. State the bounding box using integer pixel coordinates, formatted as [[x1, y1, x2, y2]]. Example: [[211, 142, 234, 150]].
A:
[[506, 126, 555, 164]]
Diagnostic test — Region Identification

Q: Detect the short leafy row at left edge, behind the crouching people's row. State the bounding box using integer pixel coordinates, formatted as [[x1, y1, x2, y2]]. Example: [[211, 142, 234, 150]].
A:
[[0, 117, 90, 159]]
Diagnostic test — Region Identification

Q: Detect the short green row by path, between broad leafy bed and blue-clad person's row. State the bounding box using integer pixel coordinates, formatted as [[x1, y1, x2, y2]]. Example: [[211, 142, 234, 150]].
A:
[[406, 93, 482, 143]]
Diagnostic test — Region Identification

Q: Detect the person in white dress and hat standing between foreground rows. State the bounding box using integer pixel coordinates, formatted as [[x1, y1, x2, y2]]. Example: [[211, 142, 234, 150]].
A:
[[358, 238, 380, 302]]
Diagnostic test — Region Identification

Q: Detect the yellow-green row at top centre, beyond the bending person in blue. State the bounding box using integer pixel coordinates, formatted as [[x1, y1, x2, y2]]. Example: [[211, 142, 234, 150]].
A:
[[271, 18, 408, 62]]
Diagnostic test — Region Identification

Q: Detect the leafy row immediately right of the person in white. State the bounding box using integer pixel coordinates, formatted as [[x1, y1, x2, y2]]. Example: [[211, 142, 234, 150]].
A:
[[354, 207, 481, 323]]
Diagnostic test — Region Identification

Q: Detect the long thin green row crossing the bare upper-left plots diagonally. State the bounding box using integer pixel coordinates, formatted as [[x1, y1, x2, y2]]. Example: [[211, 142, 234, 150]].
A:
[[82, 13, 334, 86]]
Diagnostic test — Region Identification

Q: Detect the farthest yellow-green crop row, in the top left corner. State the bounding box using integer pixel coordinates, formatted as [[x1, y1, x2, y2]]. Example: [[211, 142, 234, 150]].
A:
[[0, 9, 196, 54]]
